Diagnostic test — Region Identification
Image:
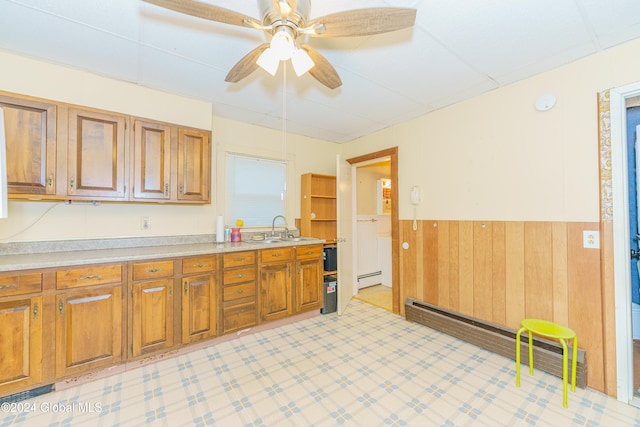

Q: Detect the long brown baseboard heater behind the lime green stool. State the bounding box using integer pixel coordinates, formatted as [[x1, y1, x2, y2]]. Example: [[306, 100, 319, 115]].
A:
[[404, 298, 587, 388]]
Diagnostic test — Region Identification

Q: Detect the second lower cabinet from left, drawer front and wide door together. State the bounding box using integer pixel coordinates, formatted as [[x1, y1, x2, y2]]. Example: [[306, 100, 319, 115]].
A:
[[55, 264, 126, 378]]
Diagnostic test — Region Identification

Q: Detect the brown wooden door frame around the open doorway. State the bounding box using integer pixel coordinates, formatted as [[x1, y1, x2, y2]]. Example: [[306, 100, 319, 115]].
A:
[[346, 147, 401, 314]]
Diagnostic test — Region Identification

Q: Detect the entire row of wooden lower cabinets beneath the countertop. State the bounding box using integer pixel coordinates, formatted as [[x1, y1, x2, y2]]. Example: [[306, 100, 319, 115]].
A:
[[0, 245, 323, 397]]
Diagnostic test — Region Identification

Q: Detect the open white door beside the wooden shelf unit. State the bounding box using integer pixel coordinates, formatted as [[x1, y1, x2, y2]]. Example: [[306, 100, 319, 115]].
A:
[[336, 155, 355, 315]]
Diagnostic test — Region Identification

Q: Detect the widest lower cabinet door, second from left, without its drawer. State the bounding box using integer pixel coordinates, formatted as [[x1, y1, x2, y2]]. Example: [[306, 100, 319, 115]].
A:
[[55, 283, 123, 378]]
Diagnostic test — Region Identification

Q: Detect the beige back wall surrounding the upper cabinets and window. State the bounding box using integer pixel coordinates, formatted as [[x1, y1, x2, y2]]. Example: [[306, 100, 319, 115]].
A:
[[0, 52, 339, 242]]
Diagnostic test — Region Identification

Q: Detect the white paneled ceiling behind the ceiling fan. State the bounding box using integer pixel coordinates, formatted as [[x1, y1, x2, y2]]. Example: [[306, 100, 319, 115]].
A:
[[0, 0, 640, 143]]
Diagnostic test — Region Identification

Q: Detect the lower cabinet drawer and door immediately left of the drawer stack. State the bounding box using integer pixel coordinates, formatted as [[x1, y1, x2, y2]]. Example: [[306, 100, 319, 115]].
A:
[[182, 255, 218, 344]]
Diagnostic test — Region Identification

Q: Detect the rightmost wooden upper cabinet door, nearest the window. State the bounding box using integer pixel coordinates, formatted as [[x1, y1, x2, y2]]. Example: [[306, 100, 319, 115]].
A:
[[177, 128, 211, 203]]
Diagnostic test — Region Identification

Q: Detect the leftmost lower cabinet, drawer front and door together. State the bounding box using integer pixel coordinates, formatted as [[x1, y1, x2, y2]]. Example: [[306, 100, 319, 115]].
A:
[[0, 273, 44, 395]]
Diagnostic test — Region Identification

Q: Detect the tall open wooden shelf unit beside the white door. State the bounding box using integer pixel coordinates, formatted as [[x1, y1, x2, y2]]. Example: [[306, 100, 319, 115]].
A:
[[300, 173, 337, 243]]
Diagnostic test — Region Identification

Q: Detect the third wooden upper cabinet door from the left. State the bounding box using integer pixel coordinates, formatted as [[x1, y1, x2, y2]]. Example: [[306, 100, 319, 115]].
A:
[[132, 120, 175, 200]]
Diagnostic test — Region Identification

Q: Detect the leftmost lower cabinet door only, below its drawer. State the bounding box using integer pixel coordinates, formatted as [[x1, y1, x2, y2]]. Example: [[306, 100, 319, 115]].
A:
[[0, 298, 43, 395]]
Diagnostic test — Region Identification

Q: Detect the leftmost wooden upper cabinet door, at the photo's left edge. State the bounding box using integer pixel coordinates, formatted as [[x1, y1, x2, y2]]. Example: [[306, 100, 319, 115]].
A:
[[0, 95, 56, 197]]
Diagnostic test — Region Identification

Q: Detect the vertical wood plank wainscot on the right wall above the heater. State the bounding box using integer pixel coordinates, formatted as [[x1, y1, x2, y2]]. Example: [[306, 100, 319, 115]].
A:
[[399, 220, 612, 392]]
